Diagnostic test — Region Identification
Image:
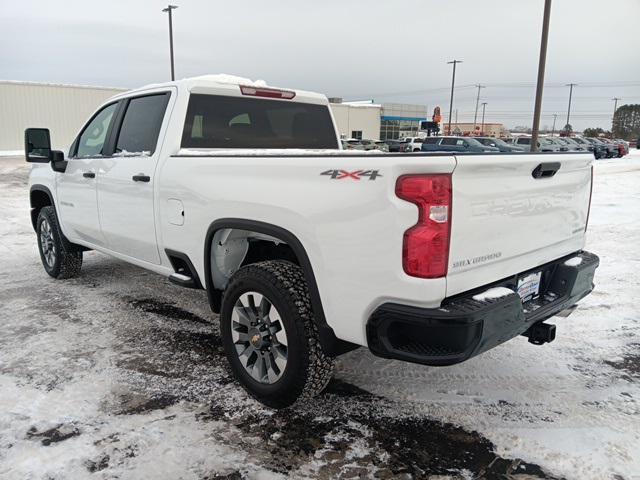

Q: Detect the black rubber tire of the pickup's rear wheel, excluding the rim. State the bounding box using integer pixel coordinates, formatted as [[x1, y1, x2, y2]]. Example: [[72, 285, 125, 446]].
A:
[[220, 260, 334, 408]]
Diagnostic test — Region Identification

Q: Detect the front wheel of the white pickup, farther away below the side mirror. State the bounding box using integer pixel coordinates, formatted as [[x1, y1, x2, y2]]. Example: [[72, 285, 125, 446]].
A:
[[36, 206, 82, 279]]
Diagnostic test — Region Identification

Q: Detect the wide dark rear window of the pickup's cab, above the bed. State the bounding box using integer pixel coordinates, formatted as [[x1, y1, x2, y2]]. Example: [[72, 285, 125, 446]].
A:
[[181, 94, 338, 149]]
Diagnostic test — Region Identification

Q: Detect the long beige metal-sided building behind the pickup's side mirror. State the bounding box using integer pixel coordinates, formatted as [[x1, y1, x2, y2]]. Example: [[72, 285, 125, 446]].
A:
[[0, 80, 125, 151]]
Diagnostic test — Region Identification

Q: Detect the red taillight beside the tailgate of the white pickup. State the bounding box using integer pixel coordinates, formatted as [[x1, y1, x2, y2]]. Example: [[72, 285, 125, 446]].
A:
[[396, 174, 451, 278]]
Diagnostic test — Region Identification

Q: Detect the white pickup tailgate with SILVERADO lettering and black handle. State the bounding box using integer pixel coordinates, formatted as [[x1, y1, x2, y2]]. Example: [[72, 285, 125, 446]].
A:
[[447, 154, 593, 296]]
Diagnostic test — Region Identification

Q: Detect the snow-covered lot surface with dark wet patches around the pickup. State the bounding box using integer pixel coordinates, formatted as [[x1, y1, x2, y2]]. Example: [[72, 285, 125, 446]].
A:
[[0, 150, 640, 480]]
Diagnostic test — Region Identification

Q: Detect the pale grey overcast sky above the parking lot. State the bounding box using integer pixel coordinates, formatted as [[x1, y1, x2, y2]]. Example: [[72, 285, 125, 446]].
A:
[[0, 0, 640, 129]]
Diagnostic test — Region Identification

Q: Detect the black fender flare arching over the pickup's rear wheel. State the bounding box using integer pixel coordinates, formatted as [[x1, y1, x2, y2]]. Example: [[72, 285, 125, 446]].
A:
[[204, 218, 359, 356]]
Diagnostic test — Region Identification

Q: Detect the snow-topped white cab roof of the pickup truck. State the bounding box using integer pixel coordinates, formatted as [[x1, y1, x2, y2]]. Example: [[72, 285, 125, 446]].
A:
[[109, 74, 329, 105]]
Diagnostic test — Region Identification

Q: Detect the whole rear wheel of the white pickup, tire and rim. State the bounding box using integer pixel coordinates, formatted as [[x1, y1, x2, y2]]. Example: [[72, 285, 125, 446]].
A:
[[220, 261, 333, 408]]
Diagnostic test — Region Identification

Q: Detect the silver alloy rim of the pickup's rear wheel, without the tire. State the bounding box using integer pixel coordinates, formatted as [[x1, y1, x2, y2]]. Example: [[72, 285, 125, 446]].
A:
[[231, 291, 289, 384]]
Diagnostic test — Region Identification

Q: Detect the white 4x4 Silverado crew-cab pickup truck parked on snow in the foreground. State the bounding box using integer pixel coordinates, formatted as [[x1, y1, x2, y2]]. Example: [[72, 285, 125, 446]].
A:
[[25, 76, 599, 408]]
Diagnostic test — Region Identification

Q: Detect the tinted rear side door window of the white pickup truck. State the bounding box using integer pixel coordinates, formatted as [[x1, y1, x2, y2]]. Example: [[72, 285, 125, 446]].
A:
[[116, 93, 169, 155]]
